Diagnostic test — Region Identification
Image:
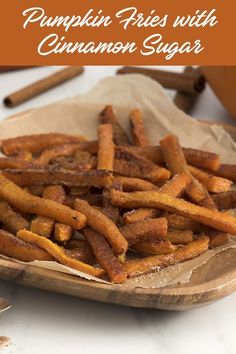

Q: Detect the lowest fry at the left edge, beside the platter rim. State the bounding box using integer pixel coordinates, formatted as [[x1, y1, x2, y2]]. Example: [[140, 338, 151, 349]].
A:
[[0, 230, 54, 262]]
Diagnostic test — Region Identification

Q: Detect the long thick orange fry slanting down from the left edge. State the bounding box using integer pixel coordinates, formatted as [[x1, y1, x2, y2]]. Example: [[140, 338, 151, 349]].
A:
[[0, 174, 86, 230]]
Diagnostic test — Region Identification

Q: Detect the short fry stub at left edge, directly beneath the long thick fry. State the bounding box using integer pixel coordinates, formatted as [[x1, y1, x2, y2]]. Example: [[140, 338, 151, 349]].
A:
[[0, 200, 29, 233]]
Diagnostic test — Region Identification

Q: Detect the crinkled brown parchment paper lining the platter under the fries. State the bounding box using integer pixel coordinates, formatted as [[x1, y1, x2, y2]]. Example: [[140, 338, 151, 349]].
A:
[[0, 74, 236, 288]]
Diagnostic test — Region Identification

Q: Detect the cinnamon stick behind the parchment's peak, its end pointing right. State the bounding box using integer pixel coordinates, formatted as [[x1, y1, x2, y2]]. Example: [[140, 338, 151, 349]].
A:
[[117, 66, 205, 93]]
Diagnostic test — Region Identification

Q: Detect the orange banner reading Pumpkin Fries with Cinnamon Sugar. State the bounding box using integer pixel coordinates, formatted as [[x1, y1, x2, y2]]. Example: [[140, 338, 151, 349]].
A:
[[0, 0, 236, 65]]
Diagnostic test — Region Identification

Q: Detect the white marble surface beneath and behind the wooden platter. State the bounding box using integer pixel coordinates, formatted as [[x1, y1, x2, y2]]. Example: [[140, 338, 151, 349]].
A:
[[0, 67, 236, 354]]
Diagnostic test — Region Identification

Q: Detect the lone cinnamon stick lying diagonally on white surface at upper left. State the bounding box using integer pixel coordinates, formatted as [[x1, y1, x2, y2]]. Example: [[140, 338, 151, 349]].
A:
[[3, 66, 84, 107]]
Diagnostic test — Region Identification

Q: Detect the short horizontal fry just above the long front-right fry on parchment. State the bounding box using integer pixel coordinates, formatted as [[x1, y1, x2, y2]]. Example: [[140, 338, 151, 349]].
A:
[[132, 240, 177, 254]]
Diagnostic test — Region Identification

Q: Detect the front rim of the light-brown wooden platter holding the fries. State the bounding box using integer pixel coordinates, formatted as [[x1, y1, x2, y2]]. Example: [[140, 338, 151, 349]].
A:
[[0, 248, 236, 310]]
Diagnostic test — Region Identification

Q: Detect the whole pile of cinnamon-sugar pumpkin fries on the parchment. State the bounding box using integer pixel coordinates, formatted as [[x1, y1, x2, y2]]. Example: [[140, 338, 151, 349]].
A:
[[0, 106, 236, 283]]
